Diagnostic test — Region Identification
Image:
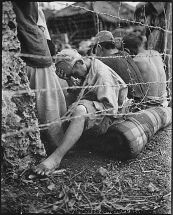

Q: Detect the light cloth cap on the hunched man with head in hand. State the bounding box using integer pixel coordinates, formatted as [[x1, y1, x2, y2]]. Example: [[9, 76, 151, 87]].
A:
[[55, 49, 82, 76]]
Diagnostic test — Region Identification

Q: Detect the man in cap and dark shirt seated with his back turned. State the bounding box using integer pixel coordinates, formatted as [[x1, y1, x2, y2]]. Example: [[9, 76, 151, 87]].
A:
[[93, 31, 145, 101]]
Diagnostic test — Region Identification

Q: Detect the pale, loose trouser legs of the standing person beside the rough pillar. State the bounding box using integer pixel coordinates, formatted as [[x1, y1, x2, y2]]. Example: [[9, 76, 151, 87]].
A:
[[27, 66, 66, 151]]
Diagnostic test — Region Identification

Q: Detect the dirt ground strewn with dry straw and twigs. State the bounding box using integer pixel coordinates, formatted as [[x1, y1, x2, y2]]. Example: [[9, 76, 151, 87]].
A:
[[1, 125, 172, 214]]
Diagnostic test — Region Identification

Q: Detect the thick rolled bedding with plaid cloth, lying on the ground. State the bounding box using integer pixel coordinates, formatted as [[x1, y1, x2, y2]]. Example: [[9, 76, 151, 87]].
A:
[[78, 107, 172, 159]]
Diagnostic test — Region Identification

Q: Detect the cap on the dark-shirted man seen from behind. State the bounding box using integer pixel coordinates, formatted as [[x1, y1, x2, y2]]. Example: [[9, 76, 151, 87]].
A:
[[95, 31, 115, 44]]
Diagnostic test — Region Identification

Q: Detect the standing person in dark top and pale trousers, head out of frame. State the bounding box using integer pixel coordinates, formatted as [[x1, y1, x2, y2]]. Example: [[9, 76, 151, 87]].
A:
[[12, 1, 66, 153]]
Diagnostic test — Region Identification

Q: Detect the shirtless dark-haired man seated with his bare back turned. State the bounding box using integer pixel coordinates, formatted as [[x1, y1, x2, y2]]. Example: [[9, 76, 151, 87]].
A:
[[123, 34, 168, 106]]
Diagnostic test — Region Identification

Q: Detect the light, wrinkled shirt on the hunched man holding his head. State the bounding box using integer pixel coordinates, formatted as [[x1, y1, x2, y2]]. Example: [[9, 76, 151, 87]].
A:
[[82, 58, 128, 118]]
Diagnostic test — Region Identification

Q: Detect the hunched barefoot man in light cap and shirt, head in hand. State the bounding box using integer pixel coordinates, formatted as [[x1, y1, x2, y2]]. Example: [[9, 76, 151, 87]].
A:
[[34, 49, 128, 175]]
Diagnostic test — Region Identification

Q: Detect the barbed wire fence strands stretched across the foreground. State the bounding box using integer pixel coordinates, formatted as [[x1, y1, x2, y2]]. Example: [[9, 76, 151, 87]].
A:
[[2, 2, 172, 140]]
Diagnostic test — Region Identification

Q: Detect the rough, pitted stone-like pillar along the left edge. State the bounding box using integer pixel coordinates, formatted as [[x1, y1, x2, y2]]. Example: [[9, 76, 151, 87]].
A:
[[1, 1, 46, 172]]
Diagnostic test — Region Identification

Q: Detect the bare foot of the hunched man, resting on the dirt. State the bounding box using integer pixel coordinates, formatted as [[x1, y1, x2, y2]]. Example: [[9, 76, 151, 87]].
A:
[[33, 153, 61, 175]]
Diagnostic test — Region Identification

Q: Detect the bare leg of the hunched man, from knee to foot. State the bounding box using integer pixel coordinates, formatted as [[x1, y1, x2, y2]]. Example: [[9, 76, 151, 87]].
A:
[[34, 105, 87, 175]]
